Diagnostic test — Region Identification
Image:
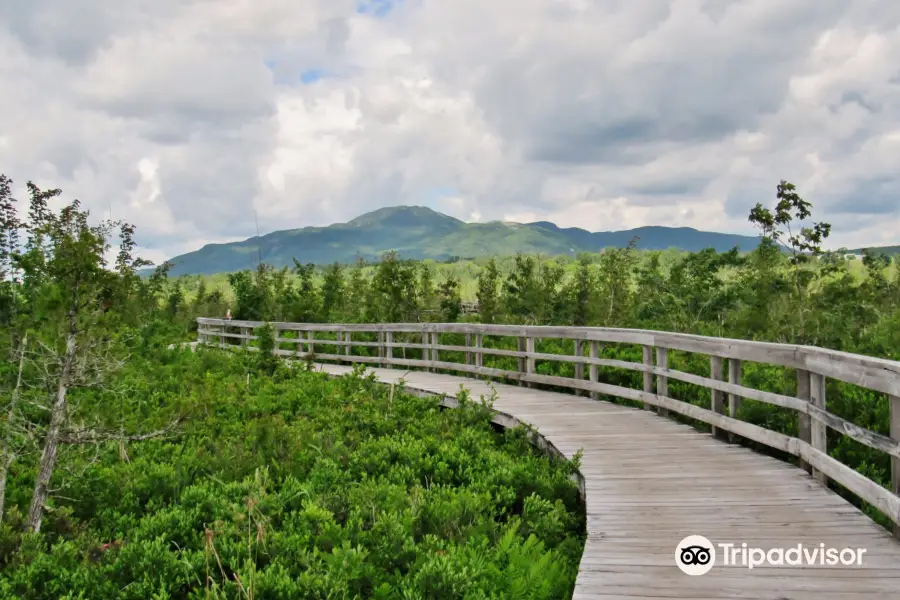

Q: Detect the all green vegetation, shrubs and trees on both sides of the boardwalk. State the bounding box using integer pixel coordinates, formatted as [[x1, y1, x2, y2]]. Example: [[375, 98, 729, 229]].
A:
[[0, 177, 900, 600]]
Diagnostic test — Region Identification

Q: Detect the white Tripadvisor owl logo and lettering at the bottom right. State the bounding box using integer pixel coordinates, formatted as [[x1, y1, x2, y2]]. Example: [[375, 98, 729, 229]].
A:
[[675, 535, 866, 575]]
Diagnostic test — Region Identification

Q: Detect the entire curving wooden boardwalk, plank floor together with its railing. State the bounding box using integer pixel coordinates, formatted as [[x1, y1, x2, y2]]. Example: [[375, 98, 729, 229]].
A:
[[198, 319, 900, 600]]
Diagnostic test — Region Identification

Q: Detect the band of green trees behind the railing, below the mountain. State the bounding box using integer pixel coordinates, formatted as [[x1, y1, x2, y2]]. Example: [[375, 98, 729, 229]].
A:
[[199, 182, 900, 358]]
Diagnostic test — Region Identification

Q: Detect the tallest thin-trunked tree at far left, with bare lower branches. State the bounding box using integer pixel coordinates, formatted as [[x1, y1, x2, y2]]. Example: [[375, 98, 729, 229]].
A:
[[3, 182, 177, 533]]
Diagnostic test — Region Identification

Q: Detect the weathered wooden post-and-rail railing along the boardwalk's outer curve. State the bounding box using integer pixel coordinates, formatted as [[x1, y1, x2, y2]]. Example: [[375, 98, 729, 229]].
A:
[[197, 318, 900, 537]]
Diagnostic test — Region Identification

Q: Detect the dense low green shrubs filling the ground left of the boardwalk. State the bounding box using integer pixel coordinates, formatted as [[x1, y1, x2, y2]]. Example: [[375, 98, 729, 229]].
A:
[[0, 350, 584, 599]]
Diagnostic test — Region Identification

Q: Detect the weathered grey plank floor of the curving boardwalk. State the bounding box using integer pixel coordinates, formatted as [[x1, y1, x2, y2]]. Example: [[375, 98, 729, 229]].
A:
[[319, 364, 900, 600]]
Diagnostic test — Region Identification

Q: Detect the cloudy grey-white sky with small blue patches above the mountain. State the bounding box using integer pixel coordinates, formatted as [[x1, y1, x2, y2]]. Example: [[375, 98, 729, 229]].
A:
[[0, 0, 900, 262]]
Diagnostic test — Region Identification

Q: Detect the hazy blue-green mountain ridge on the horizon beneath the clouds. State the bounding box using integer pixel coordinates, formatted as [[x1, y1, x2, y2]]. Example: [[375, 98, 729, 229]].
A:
[[158, 206, 759, 275]]
